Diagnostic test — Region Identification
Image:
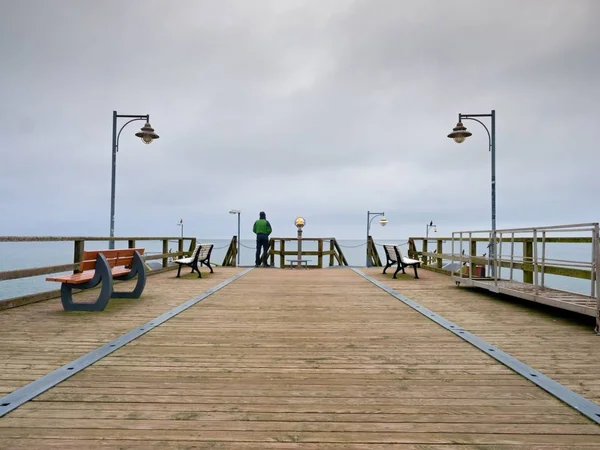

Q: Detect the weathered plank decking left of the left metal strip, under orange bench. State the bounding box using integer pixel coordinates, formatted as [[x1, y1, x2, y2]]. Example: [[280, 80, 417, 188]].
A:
[[0, 268, 244, 396]]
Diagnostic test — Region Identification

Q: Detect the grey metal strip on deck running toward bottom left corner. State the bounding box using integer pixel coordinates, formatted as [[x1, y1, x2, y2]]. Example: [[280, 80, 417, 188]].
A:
[[0, 267, 254, 417]]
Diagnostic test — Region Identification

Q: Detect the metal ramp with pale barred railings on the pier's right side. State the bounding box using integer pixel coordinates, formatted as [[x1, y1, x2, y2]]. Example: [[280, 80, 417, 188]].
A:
[[446, 223, 600, 332]]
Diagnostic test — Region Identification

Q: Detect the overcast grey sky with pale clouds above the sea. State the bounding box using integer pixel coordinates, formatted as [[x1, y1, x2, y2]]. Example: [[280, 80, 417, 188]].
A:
[[0, 0, 600, 243]]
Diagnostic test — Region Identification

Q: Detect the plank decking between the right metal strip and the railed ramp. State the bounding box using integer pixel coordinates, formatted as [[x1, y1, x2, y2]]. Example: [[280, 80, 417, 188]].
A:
[[366, 270, 600, 403]]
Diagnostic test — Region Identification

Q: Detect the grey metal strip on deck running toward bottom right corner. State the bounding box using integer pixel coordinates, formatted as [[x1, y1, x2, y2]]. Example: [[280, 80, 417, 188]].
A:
[[352, 268, 600, 424]]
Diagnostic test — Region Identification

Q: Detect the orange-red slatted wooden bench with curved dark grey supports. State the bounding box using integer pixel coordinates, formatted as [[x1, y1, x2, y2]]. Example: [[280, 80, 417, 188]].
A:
[[46, 248, 146, 311]]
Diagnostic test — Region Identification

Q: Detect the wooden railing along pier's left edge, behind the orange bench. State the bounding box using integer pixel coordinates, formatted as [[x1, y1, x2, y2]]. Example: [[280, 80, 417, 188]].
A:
[[0, 236, 196, 309]]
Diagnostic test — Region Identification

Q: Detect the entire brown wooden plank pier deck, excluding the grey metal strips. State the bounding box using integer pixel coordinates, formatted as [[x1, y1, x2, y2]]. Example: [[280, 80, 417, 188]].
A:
[[0, 268, 600, 450]]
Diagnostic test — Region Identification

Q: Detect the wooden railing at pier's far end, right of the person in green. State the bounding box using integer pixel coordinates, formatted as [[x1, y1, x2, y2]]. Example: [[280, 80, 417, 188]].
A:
[[269, 237, 348, 269]]
